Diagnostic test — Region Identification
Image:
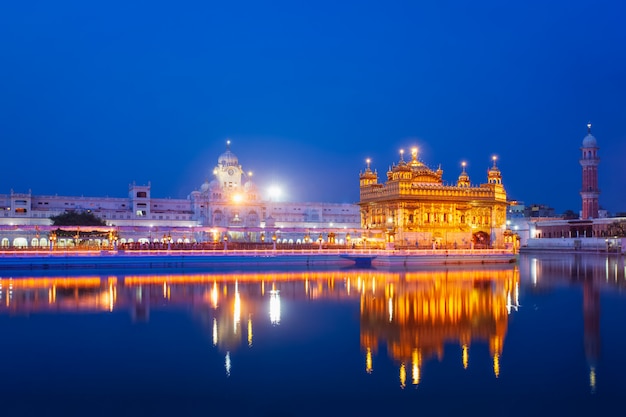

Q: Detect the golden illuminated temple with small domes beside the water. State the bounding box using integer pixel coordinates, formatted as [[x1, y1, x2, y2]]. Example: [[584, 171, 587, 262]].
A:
[[359, 148, 507, 249]]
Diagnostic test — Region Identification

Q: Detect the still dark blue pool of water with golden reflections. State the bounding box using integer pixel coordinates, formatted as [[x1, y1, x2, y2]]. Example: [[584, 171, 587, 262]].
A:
[[0, 255, 626, 416]]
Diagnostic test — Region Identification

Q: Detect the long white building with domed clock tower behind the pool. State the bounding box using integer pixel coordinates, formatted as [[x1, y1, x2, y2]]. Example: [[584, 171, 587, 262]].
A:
[[0, 142, 360, 247]]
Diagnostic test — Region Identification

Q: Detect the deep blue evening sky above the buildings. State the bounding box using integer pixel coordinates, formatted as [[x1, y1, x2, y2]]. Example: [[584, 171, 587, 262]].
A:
[[0, 0, 626, 212]]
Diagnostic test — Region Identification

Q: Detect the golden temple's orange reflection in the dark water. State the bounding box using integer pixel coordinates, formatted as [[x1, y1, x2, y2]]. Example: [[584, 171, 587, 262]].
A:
[[361, 268, 519, 387]]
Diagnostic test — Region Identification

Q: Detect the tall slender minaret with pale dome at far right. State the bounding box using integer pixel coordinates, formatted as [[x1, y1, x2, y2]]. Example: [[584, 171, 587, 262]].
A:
[[580, 123, 600, 220]]
